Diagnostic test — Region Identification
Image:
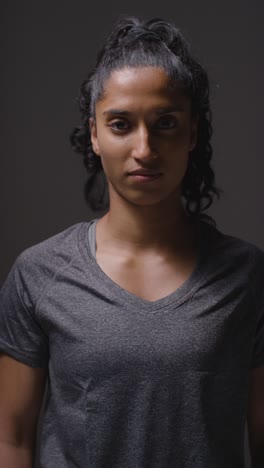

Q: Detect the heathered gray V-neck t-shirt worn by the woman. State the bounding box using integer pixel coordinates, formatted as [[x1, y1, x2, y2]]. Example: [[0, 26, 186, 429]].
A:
[[0, 219, 264, 468]]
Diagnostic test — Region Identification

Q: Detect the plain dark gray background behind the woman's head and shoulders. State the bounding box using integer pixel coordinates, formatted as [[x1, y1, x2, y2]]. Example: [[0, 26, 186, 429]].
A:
[[0, 0, 264, 464]]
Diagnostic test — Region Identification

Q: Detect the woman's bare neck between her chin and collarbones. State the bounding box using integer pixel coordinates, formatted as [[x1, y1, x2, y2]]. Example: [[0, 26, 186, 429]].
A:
[[97, 198, 198, 254]]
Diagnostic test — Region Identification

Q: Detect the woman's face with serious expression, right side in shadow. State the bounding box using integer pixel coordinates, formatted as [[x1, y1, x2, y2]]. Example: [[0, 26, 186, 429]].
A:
[[89, 67, 197, 205]]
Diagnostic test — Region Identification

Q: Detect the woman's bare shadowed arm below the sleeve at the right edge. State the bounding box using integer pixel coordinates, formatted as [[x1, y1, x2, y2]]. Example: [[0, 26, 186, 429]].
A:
[[247, 366, 264, 468]]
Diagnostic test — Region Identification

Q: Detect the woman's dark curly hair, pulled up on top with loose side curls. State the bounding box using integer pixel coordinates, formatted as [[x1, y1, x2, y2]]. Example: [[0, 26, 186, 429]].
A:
[[70, 17, 222, 225]]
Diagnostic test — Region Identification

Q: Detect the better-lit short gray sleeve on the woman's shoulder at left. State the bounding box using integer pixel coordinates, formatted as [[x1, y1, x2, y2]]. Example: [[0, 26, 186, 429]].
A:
[[0, 253, 49, 367]]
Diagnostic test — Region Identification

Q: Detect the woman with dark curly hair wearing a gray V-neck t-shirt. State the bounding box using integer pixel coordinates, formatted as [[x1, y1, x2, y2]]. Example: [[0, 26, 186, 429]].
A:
[[0, 14, 264, 468]]
